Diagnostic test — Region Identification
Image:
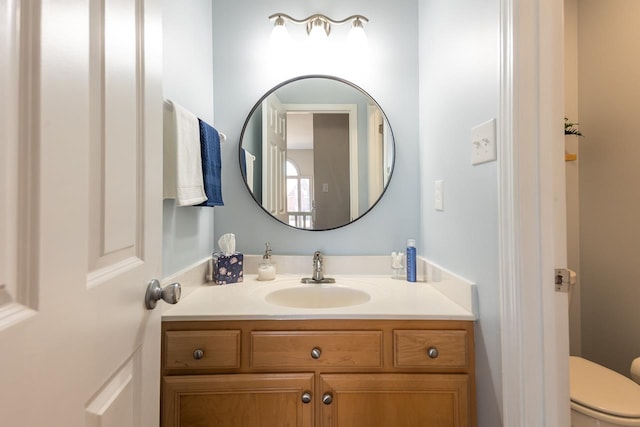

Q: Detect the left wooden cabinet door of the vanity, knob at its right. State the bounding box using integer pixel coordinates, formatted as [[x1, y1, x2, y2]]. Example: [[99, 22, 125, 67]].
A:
[[162, 373, 314, 427]]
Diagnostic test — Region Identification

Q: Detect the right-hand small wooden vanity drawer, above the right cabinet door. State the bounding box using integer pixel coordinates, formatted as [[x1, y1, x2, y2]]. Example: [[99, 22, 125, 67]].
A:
[[393, 330, 469, 369]]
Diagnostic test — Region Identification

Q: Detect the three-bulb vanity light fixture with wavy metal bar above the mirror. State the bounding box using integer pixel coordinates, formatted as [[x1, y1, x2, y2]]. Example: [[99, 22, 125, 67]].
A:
[[269, 13, 369, 43]]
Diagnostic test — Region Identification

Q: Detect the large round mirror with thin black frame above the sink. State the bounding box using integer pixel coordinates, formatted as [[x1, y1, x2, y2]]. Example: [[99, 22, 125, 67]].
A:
[[239, 76, 395, 230]]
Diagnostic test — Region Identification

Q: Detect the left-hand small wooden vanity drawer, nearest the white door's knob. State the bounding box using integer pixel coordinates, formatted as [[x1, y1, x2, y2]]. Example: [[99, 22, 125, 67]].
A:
[[164, 330, 240, 369]]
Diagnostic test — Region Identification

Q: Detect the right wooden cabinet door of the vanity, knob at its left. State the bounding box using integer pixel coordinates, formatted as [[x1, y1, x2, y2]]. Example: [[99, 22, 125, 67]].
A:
[[319, 374, 472, 427]]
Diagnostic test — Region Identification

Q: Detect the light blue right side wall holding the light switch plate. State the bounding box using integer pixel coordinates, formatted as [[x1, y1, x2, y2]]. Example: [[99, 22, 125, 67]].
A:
[[419, 0, 502, 427]]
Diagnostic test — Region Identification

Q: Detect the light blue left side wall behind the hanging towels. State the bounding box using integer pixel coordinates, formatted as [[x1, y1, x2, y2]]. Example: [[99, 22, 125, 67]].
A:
[[162, 0, 218, 277]]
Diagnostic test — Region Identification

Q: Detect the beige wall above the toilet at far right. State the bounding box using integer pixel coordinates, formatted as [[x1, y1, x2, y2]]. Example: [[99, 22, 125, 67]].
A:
[[578, 0, 640, 375]]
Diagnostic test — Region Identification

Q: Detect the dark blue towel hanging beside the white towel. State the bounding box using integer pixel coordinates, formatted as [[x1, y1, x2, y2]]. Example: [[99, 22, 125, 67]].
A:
[[198, 119, 224, 206]]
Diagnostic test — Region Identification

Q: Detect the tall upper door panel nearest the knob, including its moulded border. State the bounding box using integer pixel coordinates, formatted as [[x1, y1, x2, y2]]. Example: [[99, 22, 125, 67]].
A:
[[89, 0, 144, 278]]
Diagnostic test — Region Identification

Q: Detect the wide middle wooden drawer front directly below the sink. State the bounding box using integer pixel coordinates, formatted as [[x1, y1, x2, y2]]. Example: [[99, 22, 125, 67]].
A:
[[251, 331, 382, 368]]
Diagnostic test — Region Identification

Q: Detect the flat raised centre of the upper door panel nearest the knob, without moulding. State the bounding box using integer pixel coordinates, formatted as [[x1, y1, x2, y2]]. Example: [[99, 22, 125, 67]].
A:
[[101, 0, 141, 253]]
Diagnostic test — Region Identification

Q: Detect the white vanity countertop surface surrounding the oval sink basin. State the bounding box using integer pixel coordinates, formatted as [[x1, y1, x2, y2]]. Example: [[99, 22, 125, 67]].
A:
[[162, 275, 477, 321]]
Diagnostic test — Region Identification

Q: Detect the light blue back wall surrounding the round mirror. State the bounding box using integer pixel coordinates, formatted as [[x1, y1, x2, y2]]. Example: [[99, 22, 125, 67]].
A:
[[213, 0, 422, 256]]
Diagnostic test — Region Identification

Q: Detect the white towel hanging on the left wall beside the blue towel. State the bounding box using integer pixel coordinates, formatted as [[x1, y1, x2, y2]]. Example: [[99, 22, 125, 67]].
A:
[[163, 101, 207, 206]]
